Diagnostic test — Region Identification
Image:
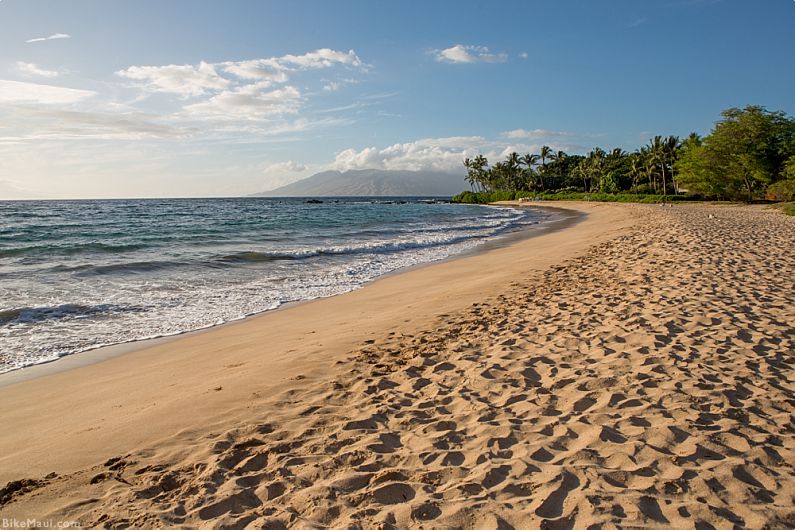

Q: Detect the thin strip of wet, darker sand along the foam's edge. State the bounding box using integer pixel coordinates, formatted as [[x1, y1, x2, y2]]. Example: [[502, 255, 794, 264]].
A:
[[0, 203, 584, 388]]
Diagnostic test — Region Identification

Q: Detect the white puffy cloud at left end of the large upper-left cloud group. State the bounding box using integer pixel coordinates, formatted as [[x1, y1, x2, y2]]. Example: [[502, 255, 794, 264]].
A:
[[116, 61, 229, 97]]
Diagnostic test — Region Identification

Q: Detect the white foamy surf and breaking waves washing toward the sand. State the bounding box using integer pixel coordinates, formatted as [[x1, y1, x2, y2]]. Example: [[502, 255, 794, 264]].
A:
[[0, 199, 543, 372]]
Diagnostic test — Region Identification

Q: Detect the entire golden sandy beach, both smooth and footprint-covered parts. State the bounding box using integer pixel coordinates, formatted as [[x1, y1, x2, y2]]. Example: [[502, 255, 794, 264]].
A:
[[0, 203, 795, 529]]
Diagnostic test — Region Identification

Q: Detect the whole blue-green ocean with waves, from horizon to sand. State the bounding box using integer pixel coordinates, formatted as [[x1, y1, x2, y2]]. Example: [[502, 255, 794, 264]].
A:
[[0, 198, 553, 373]]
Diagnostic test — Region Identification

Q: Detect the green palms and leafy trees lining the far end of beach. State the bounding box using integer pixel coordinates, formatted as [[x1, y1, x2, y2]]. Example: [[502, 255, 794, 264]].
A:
[[453, 106, 795, 203]]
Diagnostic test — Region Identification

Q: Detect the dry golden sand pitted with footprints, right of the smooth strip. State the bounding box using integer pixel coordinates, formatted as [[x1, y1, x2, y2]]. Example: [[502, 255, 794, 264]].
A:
[[0, 205, 795, 529]]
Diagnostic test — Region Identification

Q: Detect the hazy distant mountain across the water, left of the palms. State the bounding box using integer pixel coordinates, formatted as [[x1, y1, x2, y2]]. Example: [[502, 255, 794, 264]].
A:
[[253, 169, 466, 197]]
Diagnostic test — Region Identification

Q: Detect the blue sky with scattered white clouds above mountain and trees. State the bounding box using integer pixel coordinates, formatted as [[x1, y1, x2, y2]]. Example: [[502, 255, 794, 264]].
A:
[[0, 0, 795, 198]]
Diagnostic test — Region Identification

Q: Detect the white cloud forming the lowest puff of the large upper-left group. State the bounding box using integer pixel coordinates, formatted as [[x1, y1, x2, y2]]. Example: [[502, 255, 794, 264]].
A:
[[185, 82, 301, 120]]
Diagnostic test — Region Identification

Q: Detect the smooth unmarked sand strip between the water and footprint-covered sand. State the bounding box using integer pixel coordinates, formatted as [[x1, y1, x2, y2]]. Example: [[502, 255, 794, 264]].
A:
[[0, 204, 636, 483]]
